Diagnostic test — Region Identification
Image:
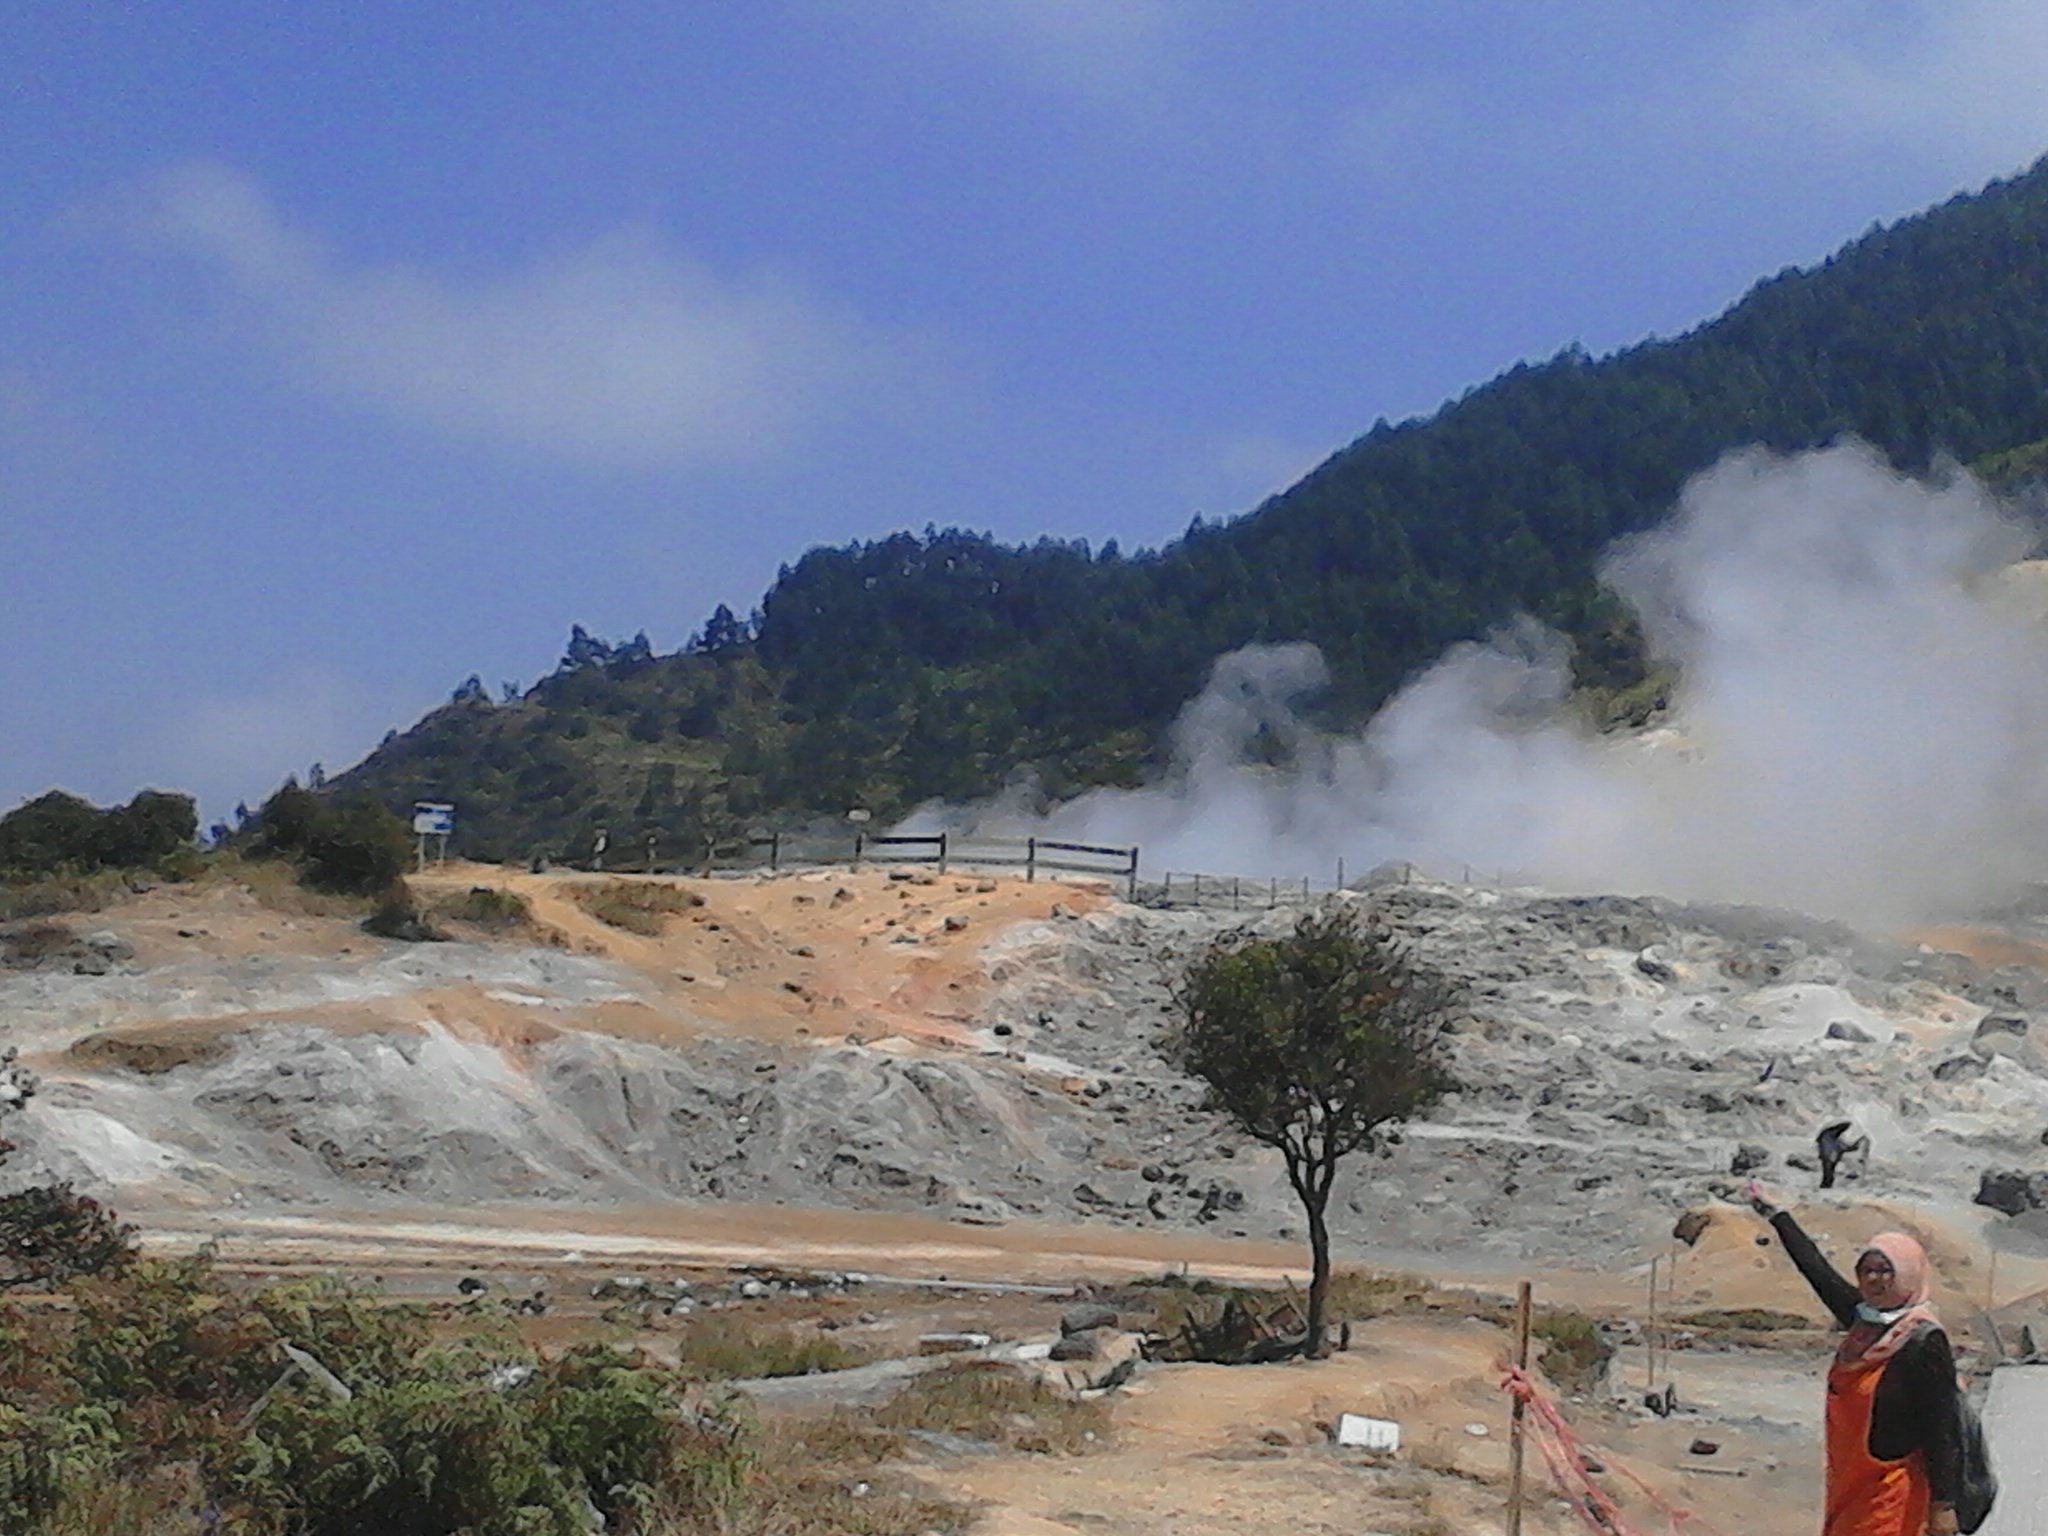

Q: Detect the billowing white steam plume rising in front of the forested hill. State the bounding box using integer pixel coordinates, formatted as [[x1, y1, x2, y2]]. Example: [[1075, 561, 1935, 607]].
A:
[[915, 444, 2048, 924]]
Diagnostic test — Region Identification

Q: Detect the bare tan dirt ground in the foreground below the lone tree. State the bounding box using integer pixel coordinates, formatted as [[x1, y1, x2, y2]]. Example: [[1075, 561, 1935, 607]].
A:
[[926, 1319, 1819, 1536]]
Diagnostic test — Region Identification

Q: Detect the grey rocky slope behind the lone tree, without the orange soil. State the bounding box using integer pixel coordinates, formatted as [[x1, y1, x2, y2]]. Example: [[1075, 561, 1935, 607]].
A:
[[0, 881, 2048, 1270]]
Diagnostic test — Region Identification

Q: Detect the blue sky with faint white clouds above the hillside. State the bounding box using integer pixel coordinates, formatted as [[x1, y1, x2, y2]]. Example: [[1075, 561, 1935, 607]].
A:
[[0, 0, 2048, 831]]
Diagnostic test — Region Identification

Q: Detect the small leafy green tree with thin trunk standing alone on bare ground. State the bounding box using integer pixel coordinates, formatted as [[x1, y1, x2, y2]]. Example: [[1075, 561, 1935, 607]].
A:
[[1167, 905, 1458, 1354]]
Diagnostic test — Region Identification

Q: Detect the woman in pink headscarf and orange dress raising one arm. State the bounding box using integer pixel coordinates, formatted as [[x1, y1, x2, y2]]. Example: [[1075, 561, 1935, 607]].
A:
[[1749, 1184, 1962, 1536]]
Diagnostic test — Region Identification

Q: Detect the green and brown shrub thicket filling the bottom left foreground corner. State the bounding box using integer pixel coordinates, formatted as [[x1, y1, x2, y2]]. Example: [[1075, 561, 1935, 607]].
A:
[[0, 1253, 950, 1536]]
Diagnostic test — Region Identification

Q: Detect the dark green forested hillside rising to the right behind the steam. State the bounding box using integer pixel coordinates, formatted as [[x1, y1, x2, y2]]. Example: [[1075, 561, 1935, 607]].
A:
[[338, 160, 2048, 872]]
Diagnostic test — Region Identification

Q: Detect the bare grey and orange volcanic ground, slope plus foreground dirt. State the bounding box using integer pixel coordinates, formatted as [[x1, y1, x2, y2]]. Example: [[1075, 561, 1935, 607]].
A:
[[0, 866, 2048, 1532]]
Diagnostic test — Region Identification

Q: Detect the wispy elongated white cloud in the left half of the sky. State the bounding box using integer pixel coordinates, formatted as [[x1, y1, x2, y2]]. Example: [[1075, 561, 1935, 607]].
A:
[[132, 164, 942, 467]]
